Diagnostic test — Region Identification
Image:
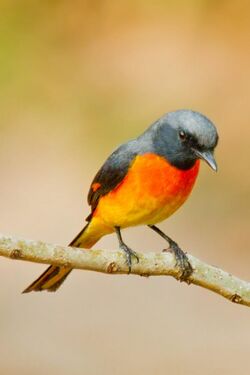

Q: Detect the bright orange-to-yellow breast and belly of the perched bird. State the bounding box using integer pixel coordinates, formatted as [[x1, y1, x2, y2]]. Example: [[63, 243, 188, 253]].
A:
[[94, 154, 200, 227]]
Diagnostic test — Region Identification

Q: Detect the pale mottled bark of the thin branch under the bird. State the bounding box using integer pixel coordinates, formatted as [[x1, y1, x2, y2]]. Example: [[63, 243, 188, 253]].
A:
[[0, 234, 250, 306]]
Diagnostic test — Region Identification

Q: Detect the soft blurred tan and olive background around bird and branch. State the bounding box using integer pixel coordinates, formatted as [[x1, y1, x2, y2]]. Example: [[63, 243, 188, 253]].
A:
[[0, 0, 250, 375]]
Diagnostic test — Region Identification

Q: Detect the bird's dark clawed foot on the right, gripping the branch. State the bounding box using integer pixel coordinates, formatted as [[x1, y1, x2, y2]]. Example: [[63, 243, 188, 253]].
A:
[[163, 241, 193, 281]]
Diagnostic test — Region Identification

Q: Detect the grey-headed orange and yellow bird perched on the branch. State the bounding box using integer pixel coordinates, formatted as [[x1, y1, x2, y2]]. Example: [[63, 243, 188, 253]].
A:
[[23, 109, 218, 293]]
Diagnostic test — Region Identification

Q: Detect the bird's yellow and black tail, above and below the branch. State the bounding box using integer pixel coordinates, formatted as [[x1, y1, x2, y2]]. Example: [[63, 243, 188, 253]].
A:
[[23, 218, 112, 293]]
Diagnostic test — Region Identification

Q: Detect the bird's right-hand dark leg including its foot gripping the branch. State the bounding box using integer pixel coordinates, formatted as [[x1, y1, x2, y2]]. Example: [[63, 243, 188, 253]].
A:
[[148, 225, 193, 281]]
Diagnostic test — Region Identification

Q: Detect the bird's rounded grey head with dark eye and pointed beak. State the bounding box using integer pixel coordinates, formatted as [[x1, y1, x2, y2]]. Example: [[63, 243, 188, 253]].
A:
[[149, 110, 218, 170]]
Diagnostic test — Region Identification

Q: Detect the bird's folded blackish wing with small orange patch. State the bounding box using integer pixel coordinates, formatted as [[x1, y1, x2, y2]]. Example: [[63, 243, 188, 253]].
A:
[[86, 141, 137, 221]]
